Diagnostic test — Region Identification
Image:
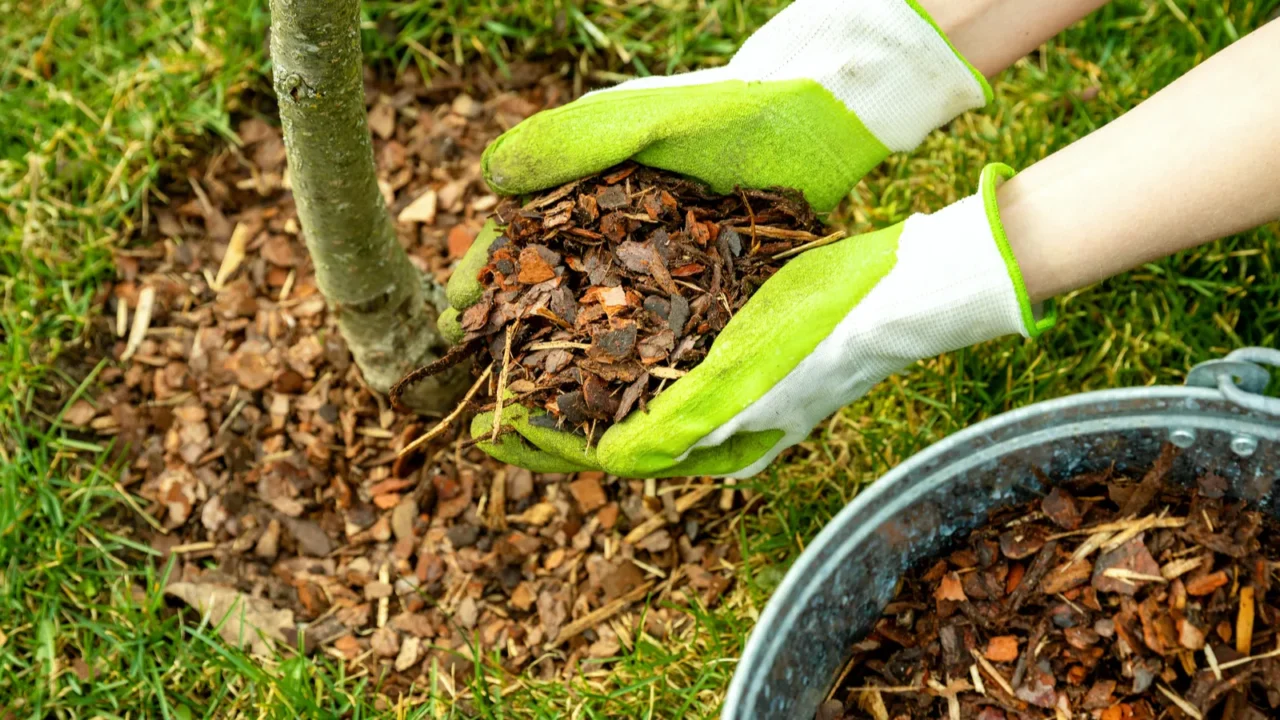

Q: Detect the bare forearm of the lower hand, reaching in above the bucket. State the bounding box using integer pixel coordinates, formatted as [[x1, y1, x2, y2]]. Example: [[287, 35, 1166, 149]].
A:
[[997, 23, 1280, 300]]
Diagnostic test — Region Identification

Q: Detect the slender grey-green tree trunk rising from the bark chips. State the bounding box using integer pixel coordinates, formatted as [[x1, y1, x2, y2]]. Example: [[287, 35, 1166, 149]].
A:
[[270, 0, 458, 411]]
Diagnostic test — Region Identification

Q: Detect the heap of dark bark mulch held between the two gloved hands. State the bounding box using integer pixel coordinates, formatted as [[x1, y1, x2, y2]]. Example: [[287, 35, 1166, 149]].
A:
[[419, 164, 842, 436]]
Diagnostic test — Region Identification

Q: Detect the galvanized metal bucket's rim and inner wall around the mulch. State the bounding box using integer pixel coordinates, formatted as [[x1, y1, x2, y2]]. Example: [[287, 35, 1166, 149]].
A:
[[722, 348, 1280, 720]]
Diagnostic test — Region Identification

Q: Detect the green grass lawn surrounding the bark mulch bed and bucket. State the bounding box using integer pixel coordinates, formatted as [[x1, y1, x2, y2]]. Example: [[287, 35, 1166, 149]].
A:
[[0, 0, 1280, 717]]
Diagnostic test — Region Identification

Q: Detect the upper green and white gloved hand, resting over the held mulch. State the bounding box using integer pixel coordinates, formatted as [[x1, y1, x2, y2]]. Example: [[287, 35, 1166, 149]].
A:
[[483, 0, 991, 211]]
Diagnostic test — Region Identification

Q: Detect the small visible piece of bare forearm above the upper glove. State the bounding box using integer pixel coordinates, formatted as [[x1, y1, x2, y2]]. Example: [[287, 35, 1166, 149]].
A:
[[920, 0, 1107, 77]]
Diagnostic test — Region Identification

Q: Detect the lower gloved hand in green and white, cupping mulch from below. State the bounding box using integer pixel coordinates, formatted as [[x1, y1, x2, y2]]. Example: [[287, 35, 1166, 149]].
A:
[[449, 164, 1053, 478]]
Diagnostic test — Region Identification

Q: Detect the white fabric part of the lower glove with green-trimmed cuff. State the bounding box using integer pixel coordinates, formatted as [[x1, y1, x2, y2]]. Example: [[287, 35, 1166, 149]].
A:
[[694, 165, 1053, 478]]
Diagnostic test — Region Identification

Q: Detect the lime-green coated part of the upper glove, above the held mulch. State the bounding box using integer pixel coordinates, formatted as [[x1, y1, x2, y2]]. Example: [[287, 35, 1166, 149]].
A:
[[481, 79, 888, 211]]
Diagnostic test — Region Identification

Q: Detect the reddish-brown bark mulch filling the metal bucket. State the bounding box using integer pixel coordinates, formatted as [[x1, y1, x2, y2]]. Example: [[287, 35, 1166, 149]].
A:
[[818, 448, 1280, 720]]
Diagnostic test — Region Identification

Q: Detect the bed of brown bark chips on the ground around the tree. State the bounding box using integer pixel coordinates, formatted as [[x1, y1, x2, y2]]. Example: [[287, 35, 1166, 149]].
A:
[[65, 67, 759, 697]]
